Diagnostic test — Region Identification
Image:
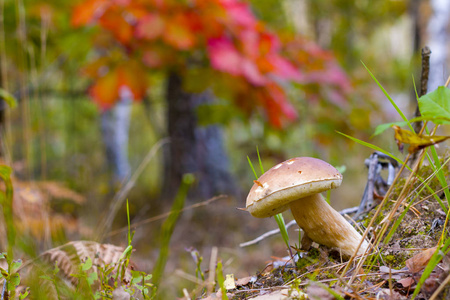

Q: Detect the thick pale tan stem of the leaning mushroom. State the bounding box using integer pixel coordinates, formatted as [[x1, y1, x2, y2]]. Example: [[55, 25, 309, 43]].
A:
[[290, 194, 369, 256]]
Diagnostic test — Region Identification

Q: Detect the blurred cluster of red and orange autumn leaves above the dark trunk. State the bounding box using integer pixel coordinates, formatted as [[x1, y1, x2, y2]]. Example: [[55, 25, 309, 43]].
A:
[[72, 0, 346, 127]]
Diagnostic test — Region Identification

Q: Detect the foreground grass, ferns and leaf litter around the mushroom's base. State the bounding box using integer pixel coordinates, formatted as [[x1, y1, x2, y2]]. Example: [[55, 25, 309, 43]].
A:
[[0, 71, 450, 299]]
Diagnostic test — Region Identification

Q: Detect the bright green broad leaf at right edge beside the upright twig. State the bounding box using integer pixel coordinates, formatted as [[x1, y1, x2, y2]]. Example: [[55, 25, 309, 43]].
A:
[[419, 86, 450, 124]]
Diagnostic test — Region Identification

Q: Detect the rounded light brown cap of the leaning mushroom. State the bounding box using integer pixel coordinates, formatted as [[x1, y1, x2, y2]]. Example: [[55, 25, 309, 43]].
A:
[[247, 157, 342, 218]]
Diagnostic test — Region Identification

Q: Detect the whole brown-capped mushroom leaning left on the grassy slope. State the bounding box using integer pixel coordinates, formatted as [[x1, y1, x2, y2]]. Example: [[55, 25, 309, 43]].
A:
[[246, 157, 368, 256]]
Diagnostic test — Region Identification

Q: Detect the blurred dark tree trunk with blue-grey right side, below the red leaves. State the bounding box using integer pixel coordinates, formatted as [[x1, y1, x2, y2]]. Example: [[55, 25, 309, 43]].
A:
[[164, 72, 237, 199]]
